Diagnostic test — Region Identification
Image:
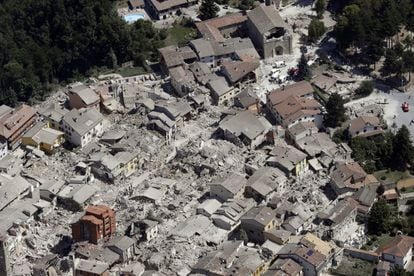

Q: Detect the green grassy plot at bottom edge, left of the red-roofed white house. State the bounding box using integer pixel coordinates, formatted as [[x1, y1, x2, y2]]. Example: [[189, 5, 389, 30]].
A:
[[330, 256, 375, 276]]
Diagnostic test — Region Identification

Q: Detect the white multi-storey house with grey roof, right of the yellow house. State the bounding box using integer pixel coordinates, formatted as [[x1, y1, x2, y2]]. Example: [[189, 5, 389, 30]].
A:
[[62, 108, 104, 147]]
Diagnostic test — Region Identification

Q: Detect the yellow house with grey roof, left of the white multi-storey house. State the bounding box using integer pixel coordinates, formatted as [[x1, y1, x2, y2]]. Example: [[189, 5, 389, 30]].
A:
[[22, 122, 65, 154]]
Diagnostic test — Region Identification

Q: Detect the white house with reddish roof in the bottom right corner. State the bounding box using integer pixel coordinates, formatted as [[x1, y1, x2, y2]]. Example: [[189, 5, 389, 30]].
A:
[[377, 235, 414, 268]]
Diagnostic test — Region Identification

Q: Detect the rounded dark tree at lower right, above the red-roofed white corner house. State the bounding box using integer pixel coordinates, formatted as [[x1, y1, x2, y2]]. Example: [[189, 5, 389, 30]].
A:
[[367, 199, 391, 235]]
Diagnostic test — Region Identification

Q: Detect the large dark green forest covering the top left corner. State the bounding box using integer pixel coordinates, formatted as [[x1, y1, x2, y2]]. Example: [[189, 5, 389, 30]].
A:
[[0, 0, 166, 106]]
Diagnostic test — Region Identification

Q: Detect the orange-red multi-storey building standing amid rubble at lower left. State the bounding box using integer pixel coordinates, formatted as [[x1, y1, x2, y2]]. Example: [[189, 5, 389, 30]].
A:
[[72, 205, 116, 244]]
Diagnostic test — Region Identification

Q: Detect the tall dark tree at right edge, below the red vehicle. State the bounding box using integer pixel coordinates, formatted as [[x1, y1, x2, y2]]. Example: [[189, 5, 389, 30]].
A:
[[391, 125, 414, 171]]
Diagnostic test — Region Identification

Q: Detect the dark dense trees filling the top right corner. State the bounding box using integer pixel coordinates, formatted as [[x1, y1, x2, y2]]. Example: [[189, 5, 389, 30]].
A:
[[334, 0, 414, 75]]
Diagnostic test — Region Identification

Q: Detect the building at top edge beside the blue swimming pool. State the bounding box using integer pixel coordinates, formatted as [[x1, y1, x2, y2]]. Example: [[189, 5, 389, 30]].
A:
[[145, 0, 198, 20]]
